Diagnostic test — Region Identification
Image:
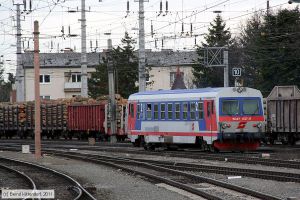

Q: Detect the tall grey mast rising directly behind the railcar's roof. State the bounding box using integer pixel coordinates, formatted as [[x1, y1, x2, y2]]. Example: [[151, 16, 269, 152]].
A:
[[135, 0, 148, 92]]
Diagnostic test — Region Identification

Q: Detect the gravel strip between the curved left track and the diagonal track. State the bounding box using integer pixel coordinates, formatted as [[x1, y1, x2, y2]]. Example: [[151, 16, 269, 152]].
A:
[[0, 151, 192, 200]]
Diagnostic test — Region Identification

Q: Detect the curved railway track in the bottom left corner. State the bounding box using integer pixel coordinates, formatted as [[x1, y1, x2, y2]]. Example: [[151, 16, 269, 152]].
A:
[[0, 157, 96, 200]]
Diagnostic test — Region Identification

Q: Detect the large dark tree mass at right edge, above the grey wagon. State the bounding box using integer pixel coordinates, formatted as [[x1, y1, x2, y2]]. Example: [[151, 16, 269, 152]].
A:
[[241, 8, 300, 95]]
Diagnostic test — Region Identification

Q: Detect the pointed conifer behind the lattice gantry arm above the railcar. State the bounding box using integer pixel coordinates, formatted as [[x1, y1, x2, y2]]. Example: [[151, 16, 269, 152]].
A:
[[193, 15, 233, 87]]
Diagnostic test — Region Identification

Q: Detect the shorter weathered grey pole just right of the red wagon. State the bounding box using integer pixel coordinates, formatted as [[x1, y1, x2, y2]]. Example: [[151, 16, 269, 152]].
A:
[[107, 39, 116, 143]]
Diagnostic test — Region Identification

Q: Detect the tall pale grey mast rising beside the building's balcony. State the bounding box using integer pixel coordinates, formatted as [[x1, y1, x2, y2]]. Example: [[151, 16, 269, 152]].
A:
[[80, 0, 88, 97]]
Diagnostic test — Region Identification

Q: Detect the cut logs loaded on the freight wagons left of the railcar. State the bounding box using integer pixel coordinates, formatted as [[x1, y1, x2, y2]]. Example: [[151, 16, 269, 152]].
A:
[[0, 94, 127, 132]]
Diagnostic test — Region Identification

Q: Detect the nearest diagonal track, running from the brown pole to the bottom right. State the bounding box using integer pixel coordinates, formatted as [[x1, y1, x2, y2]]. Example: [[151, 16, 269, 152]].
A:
[[46, 150, 280, 200]]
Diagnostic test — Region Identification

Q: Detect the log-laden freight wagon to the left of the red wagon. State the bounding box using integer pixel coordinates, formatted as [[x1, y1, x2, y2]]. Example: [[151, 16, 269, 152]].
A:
[[0, 102, 67, 138]]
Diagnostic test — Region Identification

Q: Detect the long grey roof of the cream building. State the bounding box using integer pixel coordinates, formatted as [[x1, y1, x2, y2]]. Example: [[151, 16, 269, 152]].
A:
[[22, 50, 197, 68]]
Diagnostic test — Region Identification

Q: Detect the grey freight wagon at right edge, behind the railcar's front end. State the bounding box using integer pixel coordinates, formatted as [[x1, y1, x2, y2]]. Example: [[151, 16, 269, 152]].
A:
[[266, 86, 300, 144]]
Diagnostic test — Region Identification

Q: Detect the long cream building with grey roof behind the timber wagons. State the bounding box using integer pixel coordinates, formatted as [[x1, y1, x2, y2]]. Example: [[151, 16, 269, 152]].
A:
[[22, 50, 197, 101]]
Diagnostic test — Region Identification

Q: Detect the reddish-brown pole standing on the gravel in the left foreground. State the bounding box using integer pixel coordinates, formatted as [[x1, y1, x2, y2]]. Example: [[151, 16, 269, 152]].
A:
[[33, 21, 41, 159]]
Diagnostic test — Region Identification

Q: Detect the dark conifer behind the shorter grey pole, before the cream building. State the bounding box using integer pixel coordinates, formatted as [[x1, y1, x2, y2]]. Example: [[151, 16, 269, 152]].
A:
[[89, 32, 138, 98]]
